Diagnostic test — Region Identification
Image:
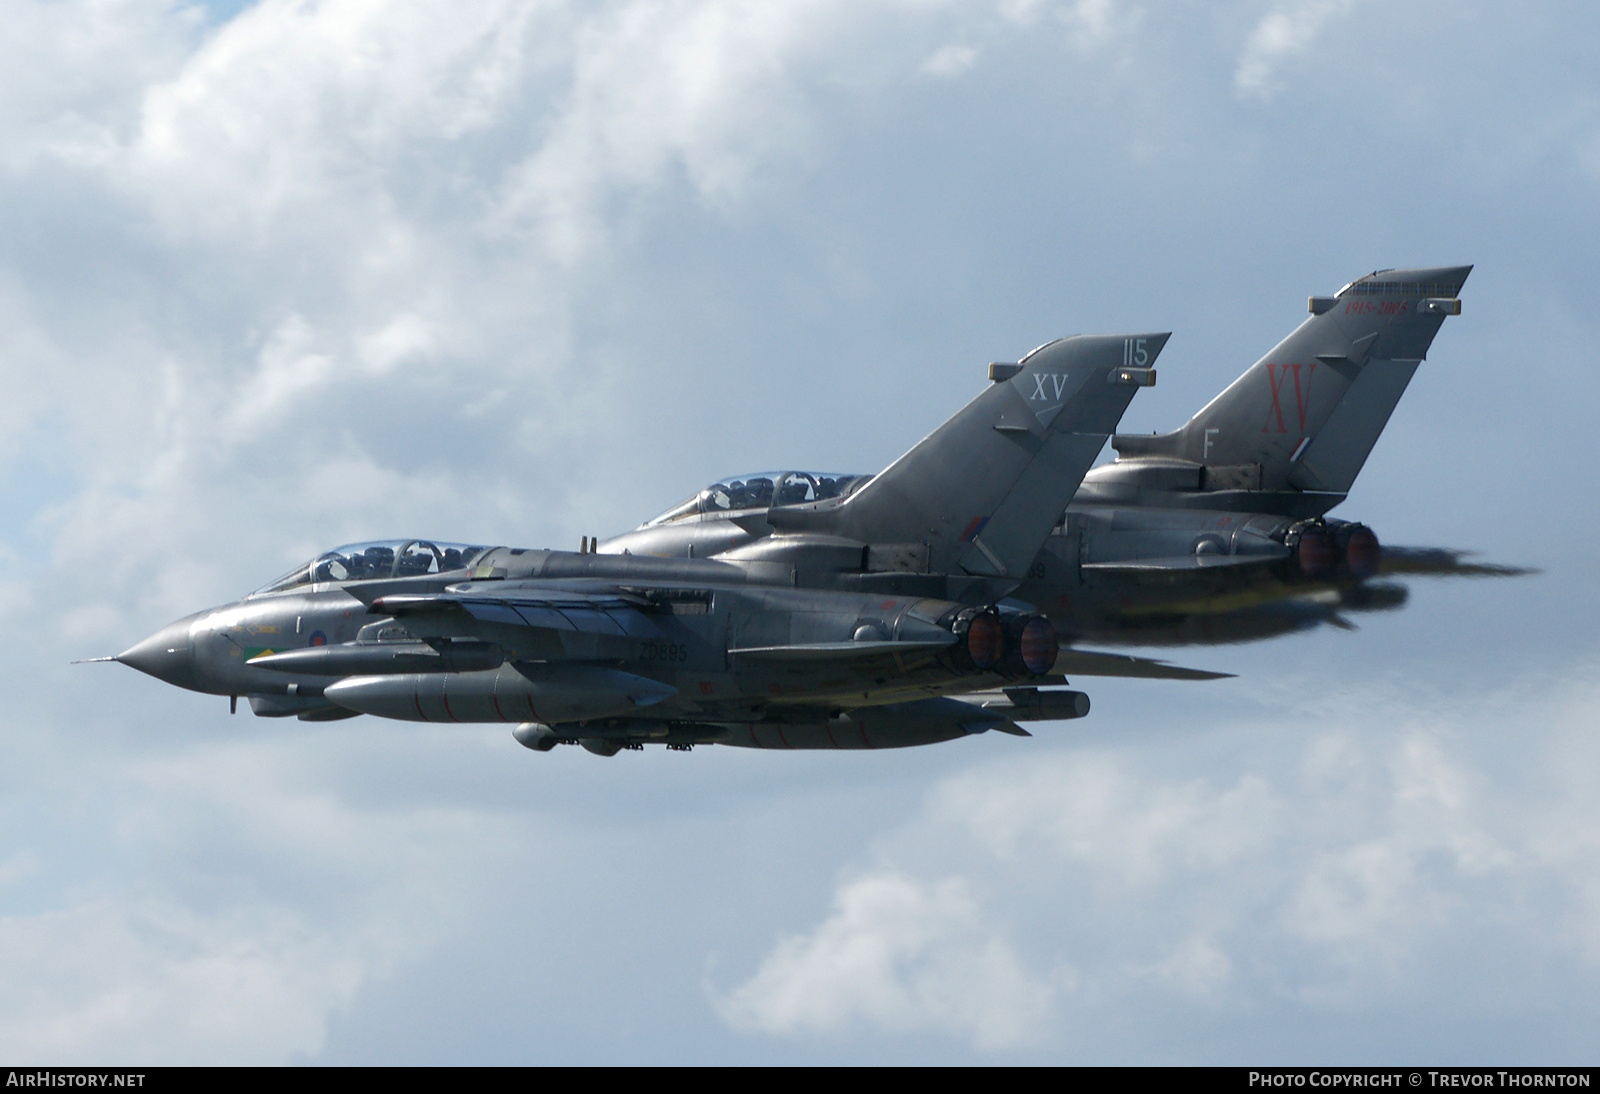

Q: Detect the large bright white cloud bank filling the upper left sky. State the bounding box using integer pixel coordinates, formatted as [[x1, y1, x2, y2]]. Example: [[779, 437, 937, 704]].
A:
[[0, 0, 1036, 629]]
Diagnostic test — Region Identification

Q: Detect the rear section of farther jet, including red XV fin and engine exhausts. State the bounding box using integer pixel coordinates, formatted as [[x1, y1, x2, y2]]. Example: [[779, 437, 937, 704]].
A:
[[1016, 266, 1526, 645]]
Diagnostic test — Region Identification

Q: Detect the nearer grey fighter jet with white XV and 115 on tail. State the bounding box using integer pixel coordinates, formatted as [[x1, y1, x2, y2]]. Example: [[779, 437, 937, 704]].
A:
[[114, 334, 1218, 755]]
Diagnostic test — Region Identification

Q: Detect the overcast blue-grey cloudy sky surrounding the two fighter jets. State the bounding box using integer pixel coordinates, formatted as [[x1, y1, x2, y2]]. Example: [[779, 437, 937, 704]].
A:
[[0, 0, 1600, 1064]]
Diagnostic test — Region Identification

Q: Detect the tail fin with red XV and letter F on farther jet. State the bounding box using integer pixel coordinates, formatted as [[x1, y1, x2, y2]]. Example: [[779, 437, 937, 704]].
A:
[[1112, 266, 1472, 497]]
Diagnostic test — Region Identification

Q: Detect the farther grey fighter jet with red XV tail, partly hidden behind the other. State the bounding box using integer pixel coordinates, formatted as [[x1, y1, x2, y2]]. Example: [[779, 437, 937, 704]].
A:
[[598, 266, 1525, 649]]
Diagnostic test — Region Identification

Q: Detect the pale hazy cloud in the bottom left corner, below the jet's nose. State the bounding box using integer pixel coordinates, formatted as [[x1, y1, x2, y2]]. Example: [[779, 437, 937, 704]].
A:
[[0, 729, 525, 1064]]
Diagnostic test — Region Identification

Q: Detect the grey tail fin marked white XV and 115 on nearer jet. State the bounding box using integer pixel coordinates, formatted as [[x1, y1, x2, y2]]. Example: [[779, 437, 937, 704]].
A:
[[832, 334, 1168, 577]]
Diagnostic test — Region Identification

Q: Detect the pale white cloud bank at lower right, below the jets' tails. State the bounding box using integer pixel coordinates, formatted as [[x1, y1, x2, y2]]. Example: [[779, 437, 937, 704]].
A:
[[718, 673, 1600, 1059]]
